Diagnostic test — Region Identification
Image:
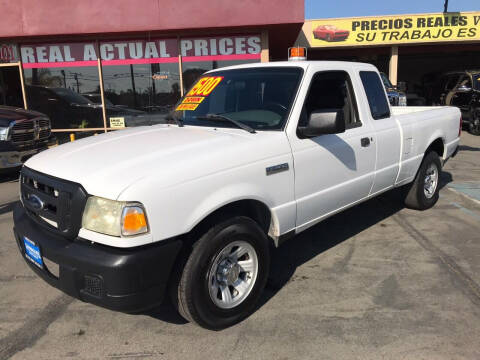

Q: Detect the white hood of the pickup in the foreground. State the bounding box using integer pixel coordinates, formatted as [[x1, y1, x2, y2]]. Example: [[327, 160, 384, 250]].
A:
[[25, 125, 288, 200]]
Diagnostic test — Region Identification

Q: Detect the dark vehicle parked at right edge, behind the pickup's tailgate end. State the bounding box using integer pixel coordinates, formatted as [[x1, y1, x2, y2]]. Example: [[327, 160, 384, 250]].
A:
[[433, 70, 480, 135]]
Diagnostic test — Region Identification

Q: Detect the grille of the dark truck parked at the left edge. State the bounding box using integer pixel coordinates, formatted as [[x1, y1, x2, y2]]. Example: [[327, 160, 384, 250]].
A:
[[11, 118, 51, 145]]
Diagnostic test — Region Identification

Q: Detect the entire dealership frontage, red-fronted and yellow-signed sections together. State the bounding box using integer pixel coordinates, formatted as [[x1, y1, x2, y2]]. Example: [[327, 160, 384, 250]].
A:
[[0, 0, 480, 142]]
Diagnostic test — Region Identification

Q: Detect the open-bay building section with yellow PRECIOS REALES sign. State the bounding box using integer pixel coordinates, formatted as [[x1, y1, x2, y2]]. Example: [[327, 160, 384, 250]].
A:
[[296, 12, 480, 105]]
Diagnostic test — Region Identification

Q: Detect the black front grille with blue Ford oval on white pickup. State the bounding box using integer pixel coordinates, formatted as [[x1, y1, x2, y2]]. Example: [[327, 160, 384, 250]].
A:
[[20, 167, 87, 239]]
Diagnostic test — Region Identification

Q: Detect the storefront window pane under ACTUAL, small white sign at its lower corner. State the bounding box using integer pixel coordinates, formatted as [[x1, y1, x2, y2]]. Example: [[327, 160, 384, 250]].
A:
[[103, 63, 180, 127]]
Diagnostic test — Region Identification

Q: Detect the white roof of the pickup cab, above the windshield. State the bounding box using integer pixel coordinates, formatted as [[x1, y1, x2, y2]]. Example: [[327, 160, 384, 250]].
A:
[[207, 60, 377, 73]]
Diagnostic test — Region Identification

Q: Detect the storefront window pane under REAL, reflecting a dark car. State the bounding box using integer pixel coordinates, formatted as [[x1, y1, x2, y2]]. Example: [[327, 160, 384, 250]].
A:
[[24, 66, 103, 129]]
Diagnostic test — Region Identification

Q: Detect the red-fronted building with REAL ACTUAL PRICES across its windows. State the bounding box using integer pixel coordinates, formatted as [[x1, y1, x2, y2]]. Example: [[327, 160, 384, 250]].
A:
[[0, 0, 304, 142]]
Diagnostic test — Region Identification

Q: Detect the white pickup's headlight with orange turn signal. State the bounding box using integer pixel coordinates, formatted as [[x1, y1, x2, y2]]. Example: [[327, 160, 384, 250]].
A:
[[82, 196, 148, 236]]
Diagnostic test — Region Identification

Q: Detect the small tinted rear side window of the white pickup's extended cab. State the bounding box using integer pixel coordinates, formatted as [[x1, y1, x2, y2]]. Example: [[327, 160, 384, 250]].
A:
[[360, 71, 390, 120]]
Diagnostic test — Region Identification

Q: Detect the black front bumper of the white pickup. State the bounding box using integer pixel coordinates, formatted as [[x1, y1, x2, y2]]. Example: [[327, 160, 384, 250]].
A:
[[13, 204, 182, 312]]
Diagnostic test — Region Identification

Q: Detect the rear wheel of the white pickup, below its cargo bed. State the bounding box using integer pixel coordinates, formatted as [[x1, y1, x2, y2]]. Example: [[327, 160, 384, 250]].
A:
[[405, 151, 442, 210]]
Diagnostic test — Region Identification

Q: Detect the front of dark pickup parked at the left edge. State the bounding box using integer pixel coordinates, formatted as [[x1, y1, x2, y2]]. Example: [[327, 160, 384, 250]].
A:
[[0, 106, 51, 172]]
